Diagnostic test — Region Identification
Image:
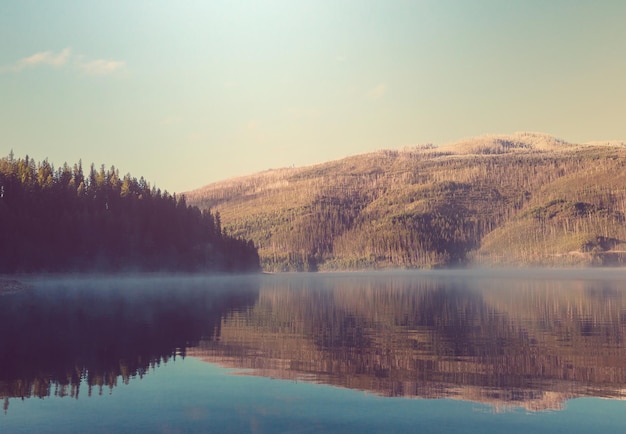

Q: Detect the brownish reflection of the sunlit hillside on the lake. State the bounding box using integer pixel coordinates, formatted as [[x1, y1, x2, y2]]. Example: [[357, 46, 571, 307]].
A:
[[188, 273, 626, 410]]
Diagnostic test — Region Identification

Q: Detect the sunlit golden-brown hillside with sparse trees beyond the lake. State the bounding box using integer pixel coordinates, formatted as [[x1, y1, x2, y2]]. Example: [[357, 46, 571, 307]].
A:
[[187, 133, 626, 271]]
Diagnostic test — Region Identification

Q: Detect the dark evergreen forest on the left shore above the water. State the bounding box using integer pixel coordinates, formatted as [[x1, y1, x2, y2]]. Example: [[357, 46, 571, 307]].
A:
[[0, 153, 259, 273]]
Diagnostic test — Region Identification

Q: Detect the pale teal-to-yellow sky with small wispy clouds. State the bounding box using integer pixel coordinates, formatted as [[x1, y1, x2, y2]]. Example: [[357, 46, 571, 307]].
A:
[[0, 0, 626, 193]]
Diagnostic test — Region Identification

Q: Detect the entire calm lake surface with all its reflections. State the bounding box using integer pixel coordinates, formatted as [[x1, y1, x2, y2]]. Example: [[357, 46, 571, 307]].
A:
[[0, 270, 626, 433]]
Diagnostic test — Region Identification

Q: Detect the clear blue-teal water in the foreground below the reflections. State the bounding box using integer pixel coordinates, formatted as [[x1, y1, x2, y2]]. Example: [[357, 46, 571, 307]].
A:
[[0, 357, 626, 434]]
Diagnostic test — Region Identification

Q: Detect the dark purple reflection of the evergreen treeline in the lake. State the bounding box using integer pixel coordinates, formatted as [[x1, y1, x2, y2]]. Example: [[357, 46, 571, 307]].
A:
[[0, 276, 258, 411]]
